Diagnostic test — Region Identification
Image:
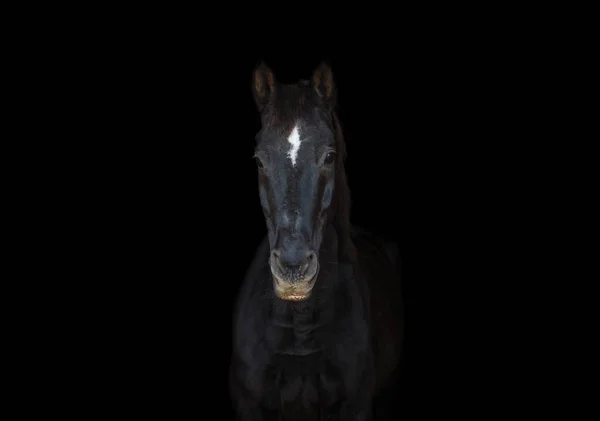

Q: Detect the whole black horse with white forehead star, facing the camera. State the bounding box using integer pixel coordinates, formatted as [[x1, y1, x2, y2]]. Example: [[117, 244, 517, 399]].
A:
[[230, 63, 403, 421]]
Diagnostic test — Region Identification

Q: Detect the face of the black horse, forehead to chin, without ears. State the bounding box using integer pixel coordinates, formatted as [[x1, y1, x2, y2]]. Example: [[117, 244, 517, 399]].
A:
[[254, 60, 336, 301]]
